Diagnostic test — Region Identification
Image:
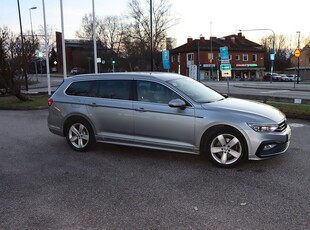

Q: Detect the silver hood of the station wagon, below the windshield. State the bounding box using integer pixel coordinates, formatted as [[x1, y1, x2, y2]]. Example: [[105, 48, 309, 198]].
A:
[[202, 98, 285, 122]]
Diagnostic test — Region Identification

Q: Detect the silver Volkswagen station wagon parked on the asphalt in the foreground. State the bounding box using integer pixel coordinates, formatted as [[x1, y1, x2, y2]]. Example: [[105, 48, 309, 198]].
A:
[[48, 72, 291, 167]]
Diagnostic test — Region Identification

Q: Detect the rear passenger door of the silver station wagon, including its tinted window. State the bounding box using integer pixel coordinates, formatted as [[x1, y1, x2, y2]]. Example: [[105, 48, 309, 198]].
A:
[[87, 79, 134, 143]]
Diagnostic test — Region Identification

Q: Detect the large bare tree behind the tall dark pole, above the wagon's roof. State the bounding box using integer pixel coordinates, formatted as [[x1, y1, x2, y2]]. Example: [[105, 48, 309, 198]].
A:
[[125, 0, 176, 69]]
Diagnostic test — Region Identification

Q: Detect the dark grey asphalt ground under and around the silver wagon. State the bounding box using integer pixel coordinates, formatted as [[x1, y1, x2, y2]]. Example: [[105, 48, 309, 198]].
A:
[[0, 110, 310, 230]]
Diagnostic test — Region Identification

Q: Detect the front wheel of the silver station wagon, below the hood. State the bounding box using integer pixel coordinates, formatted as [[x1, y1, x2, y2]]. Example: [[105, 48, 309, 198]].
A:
[[206, 127, 248, 168]]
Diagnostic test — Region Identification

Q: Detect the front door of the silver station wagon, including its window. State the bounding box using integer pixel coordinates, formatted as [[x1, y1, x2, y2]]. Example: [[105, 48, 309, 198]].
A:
[[133, 80, 195, 152]]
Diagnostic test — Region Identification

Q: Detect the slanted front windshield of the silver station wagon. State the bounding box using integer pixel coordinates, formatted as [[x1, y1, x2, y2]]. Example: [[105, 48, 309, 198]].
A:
[[168, 77, 224, 103]]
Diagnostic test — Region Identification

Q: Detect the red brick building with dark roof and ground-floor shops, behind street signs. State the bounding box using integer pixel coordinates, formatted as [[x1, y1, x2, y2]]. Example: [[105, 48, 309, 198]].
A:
[[170, 33, 265, 80]]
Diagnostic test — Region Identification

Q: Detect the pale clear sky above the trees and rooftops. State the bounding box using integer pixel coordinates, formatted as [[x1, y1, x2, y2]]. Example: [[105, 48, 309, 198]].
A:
[[0, 0, 310, 48]]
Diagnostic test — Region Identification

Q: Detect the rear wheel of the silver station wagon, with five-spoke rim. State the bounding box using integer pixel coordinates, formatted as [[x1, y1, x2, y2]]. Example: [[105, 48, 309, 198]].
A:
[[66, 120, 95, 152]]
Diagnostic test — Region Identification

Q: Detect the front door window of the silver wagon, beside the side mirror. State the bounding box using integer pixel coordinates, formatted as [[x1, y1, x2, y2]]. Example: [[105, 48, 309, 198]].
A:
[[137, 81, 180, 104]]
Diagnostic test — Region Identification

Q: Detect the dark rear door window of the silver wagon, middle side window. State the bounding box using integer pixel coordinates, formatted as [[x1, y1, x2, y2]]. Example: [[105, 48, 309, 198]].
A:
[[98, 80, 131, 100]]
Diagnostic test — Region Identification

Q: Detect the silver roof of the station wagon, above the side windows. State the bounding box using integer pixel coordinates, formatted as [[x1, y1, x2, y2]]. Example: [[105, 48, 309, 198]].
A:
[[66, 72, 184, 81]]
